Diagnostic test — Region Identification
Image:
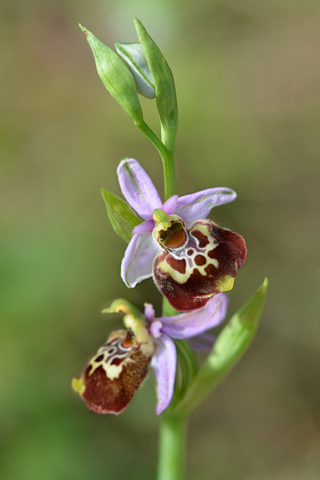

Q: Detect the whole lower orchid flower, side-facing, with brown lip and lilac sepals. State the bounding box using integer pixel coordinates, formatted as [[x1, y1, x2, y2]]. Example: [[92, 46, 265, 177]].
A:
[[73, 293, 228, 415]]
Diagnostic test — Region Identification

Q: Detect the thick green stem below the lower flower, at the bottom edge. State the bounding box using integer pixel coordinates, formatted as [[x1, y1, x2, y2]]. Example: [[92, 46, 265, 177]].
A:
[[157, 411, 187, 480]]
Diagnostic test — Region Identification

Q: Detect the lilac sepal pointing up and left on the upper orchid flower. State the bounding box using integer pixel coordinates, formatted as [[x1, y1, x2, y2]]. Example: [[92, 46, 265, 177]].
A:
[[117, 158, 162, 220]]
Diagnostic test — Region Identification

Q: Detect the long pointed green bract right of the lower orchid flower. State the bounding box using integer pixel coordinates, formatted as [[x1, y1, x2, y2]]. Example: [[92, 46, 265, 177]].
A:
[[175, 278, 268, 414]]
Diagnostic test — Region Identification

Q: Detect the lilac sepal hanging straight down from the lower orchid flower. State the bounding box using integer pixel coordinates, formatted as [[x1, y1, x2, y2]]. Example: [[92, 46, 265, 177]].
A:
[[151, 335, 177, 415]]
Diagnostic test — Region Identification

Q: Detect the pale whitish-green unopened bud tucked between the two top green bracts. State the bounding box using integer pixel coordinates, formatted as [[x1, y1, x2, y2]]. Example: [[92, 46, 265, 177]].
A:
[[115, 42, 156, 99]]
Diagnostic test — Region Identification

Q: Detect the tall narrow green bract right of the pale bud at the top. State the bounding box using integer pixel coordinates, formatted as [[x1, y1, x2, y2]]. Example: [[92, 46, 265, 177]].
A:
[[133, 18, 178, 151]]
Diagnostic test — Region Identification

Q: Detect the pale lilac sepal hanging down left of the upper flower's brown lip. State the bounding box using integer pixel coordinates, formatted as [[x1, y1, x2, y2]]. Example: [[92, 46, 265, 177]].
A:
[[121, 233, 161, 288]]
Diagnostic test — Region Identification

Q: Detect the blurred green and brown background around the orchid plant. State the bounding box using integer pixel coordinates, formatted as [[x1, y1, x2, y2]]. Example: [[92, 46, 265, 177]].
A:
[[0, 0, 320, 480]]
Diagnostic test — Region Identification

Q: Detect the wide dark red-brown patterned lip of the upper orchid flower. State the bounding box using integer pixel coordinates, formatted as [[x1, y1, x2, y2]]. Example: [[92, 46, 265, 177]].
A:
[[153, 217, 247, 312]]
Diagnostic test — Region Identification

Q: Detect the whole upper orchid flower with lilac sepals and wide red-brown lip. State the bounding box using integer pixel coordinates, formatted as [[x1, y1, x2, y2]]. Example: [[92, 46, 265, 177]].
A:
[[118, 159, 246, 311]]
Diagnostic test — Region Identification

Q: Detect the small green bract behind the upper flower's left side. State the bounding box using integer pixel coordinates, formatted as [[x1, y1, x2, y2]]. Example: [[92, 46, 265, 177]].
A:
[[101, 188, 143, 243]]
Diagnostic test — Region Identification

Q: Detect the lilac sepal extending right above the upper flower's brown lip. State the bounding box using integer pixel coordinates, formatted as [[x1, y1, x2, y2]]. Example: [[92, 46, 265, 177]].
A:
[[174, 187, 237, 223]]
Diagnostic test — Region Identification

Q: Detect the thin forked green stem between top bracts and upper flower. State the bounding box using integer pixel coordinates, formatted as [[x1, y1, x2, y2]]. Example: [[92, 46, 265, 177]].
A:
[[138, 122, 178, 200]]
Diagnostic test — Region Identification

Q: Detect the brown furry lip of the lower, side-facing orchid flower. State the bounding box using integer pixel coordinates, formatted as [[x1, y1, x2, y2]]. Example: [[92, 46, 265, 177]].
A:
[[73, 327, 153, 414]]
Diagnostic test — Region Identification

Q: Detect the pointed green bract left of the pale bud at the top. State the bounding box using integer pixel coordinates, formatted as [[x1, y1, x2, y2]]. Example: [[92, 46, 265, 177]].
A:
[[80, 25, 143, 125]]
